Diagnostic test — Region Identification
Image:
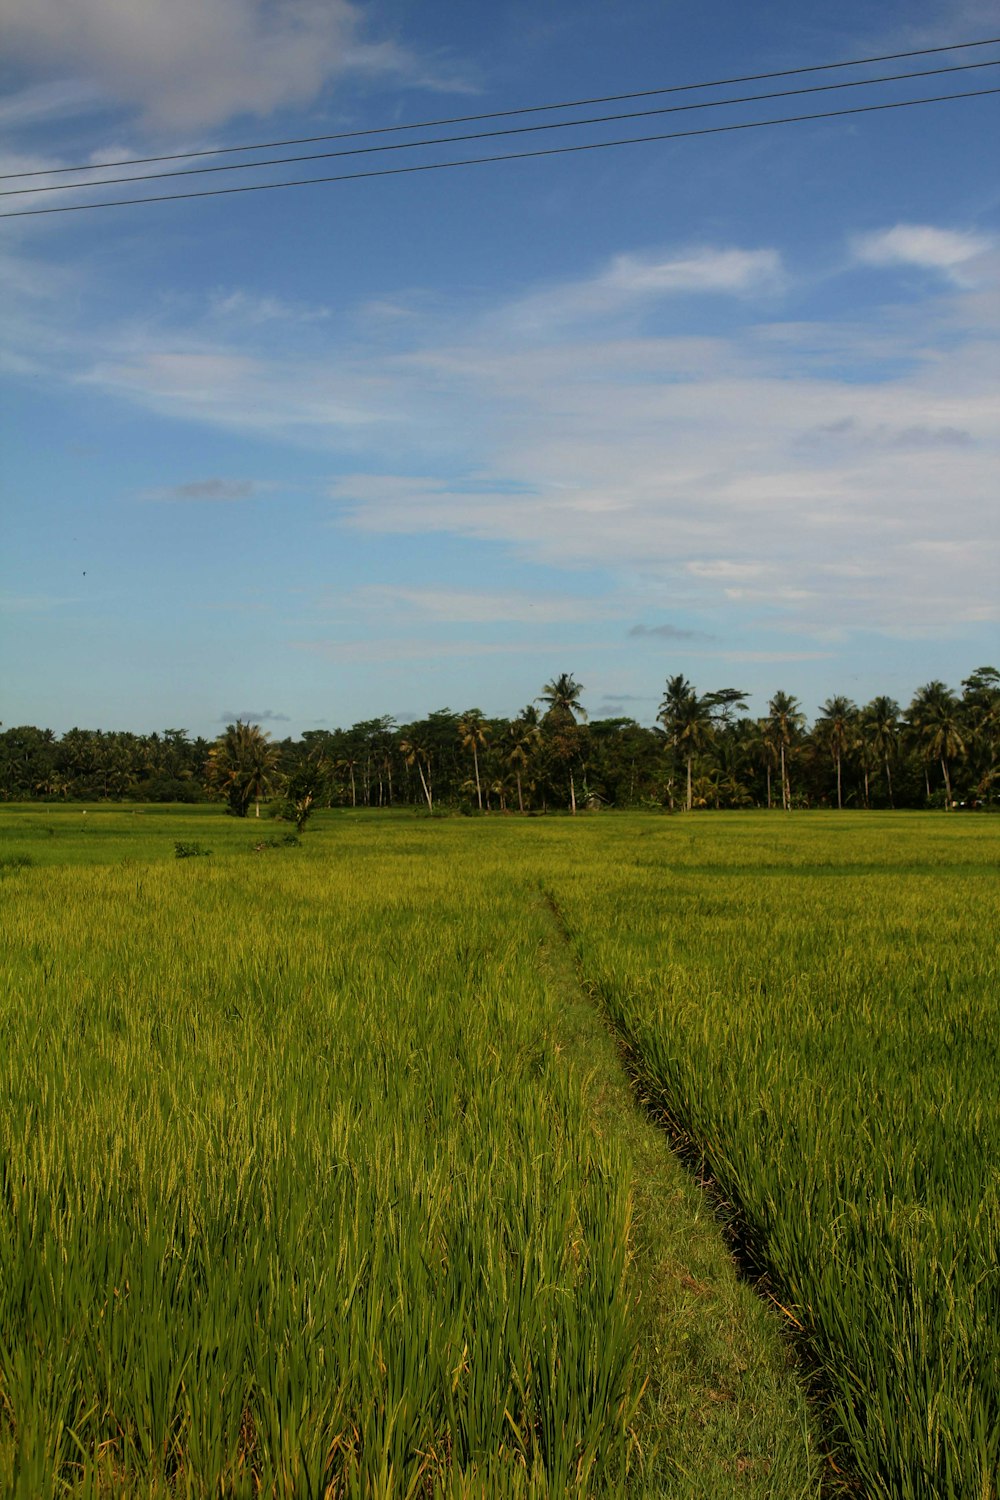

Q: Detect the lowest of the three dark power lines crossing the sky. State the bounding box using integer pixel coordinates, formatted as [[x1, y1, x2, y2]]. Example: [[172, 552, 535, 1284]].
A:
[[0, 87, 1000, 219]]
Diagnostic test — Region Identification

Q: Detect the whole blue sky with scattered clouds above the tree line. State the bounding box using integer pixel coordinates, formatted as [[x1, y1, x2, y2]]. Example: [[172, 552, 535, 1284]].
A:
[[0, 0, 1000, 735]]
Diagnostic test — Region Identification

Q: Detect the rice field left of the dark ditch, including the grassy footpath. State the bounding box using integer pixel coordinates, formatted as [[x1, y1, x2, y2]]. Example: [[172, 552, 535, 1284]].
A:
[[0, 807, 816, 1500]]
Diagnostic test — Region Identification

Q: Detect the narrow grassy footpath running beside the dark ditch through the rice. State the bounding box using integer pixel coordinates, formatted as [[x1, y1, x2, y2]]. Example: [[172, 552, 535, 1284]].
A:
[[543, 905, 820, 1500]]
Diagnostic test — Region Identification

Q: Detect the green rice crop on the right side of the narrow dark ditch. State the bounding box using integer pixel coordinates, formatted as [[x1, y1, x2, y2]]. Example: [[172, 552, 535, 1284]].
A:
[[553, 815, 1000, 1500]]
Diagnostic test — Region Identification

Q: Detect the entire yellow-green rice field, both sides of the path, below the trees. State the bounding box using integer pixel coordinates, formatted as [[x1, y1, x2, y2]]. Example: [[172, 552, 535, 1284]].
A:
[[0, 806, 1000, 1500]]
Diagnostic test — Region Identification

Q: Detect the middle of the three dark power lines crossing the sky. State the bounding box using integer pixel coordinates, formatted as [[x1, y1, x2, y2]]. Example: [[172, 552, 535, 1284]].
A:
[[0, 57, 1000, 198]]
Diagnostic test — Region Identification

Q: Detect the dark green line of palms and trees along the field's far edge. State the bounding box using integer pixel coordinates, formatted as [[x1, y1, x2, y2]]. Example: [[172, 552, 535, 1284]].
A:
[[0, 666, 1000, 827]]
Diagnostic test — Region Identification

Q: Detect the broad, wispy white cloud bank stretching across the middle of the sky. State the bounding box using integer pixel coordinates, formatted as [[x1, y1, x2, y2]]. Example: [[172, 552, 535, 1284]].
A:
[[7, 234, 1000, 639]]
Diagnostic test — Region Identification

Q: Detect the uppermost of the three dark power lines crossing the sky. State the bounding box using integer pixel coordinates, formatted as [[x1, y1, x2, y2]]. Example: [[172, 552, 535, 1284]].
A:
[[0, 36, 1000, 182]]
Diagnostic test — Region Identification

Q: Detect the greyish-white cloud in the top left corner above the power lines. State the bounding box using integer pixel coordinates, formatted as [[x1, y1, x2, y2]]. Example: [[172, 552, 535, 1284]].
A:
[[0, 0, 470, 131]]
